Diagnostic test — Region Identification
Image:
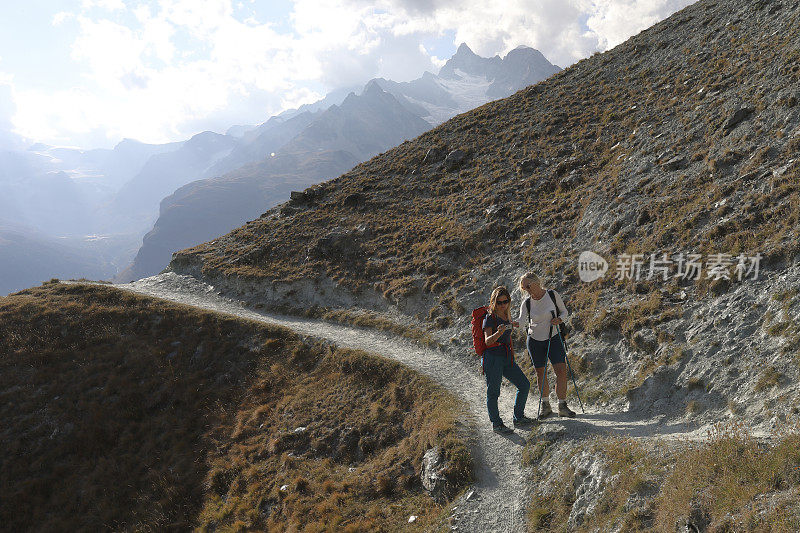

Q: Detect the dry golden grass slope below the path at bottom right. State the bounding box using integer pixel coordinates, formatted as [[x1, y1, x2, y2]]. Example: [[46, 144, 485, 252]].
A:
[[527, 425, 800, 533]]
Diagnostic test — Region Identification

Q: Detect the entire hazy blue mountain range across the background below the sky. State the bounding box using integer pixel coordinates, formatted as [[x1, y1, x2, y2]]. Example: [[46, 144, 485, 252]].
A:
[[0, 44, 560, 294]]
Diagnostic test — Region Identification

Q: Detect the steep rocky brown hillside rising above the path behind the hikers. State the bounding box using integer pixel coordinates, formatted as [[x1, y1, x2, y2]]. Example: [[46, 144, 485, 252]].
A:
[[171, 0, 800, 425]]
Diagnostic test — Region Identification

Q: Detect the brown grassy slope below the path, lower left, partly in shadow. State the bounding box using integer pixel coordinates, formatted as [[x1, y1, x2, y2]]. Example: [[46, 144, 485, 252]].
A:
[[0, 284, 471, 531]]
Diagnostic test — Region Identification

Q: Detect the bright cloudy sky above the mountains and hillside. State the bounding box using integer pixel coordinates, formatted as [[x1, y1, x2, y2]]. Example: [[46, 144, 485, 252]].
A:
[[0, 0, 693, 148]]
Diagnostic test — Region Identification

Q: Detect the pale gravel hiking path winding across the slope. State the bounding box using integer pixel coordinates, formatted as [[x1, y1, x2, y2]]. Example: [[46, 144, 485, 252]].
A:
[[92, 273, 712, 532]]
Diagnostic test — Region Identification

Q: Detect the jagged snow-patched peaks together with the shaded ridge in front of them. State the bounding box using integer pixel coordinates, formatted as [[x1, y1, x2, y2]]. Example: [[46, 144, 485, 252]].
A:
[[117, 44, 561, 281]]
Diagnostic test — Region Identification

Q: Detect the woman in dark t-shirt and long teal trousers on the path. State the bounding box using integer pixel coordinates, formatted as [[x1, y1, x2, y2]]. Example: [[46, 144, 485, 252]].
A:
[[482, 287, 533, 434]]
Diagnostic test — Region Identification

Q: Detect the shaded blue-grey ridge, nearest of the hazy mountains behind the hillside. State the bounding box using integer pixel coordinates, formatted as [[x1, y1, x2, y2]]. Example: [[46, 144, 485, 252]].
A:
[[116, 83, 429, 282]]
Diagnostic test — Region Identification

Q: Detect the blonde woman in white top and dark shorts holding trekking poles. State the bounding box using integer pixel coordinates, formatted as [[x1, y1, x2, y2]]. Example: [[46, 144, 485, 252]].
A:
[[519, 272, 575, 418]]
